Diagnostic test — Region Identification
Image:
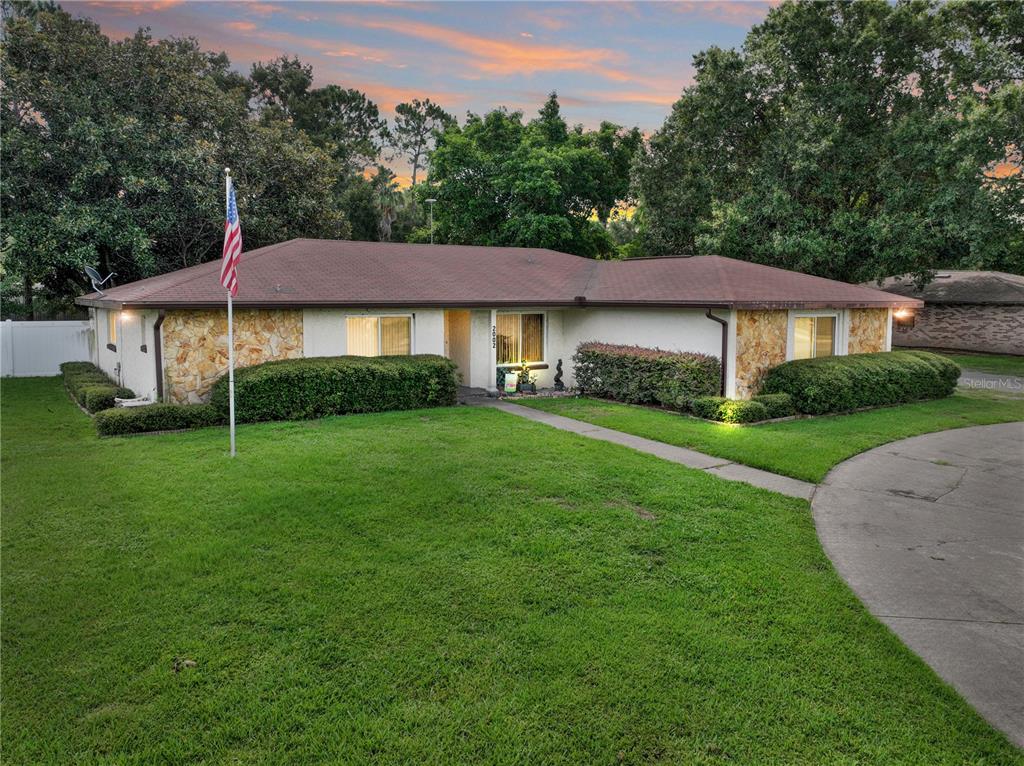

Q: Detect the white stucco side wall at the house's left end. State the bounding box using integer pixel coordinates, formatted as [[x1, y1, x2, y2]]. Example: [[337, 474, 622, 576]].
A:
[[91, 308, 158, 399]]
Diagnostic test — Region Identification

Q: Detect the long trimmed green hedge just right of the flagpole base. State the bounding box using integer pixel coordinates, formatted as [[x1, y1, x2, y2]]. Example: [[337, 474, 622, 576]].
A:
[[210, 354, 459, 423]]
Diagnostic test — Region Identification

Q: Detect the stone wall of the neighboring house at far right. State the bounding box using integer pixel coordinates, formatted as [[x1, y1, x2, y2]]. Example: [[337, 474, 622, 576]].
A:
[[893, 303, 1024, 354]]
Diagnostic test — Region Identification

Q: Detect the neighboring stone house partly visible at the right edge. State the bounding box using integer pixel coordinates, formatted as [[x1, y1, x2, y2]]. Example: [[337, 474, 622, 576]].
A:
[[882, 270, 1024, 354]]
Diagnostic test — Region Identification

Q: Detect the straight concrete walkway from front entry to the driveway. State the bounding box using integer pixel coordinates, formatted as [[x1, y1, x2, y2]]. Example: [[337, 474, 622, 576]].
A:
[[485, 398, 815, 500]]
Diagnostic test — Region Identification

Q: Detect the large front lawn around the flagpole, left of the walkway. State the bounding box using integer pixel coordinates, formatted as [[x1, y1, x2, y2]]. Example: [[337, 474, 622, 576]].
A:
[[2, 379, 1022, 764]]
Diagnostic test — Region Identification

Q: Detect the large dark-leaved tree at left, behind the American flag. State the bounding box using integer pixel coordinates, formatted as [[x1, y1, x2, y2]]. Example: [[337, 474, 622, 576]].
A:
[[0, 6, 348, 310]]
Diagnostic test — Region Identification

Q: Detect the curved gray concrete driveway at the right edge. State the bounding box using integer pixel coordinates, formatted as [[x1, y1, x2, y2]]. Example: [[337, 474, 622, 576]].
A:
[[812, 423, 1024, 747]]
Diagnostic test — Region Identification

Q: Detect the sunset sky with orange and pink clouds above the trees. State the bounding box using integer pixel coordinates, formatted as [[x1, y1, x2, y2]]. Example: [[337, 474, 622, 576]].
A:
[[68, 0, 772, 180]]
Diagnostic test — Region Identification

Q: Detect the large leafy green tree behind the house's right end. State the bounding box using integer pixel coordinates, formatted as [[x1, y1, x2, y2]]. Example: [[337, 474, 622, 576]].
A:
[[634, 0, 1024, 282]]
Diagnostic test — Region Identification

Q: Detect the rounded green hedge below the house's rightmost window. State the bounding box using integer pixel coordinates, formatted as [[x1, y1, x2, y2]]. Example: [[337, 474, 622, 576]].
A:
[[761, 351, 959, 415]]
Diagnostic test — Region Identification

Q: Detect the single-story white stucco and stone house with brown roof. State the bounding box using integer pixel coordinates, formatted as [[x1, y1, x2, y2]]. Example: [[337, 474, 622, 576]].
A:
[[78, 240, 921, 402]]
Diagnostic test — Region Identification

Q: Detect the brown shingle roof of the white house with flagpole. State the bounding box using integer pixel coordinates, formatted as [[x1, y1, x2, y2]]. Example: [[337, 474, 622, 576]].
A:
[[78, 240, 920, 308]]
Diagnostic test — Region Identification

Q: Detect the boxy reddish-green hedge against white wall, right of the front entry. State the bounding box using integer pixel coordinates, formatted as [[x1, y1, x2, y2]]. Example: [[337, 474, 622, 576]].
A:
[[572, 343, 722, 410]]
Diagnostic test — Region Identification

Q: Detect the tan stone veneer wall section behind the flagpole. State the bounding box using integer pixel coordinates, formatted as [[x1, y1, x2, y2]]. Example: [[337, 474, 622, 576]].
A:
[[161, 309, 302, 405]]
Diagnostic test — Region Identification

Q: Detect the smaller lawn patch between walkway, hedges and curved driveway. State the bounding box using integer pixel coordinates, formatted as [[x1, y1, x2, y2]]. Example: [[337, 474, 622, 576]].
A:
[[519, 391, 1024, 482]]
